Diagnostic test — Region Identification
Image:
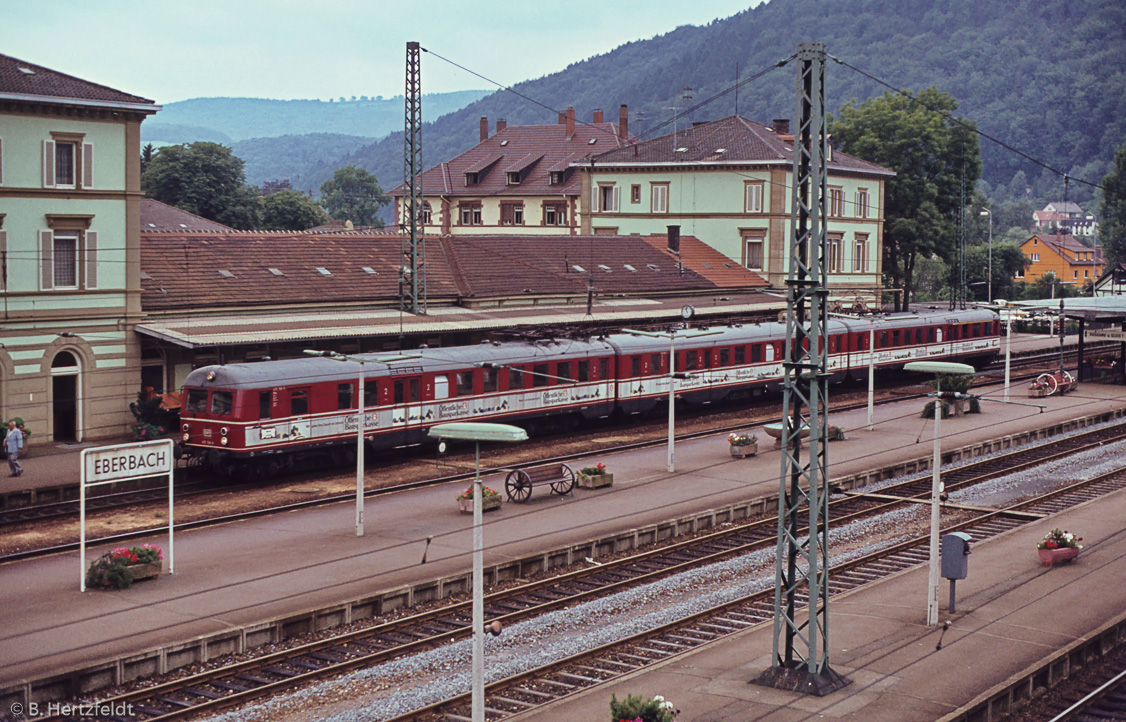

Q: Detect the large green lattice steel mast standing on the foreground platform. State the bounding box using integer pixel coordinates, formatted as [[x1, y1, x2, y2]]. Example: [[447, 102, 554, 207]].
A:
[[754, 43, 849, 696]]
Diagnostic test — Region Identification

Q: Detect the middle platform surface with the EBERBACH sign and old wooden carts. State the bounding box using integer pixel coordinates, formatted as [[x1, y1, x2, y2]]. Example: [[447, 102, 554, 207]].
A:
[[0, 342, 1126, 719]]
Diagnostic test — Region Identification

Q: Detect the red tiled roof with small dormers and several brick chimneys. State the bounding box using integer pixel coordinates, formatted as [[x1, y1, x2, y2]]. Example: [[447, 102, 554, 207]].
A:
[[391, 123, 633, 197]]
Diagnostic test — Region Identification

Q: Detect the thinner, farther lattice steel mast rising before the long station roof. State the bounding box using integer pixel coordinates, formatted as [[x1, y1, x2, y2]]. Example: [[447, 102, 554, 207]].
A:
[[399, 42, 426, 313]]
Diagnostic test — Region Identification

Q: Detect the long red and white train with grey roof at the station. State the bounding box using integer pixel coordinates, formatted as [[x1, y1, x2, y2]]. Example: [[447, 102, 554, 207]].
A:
[[178, 311, 1000, 474]]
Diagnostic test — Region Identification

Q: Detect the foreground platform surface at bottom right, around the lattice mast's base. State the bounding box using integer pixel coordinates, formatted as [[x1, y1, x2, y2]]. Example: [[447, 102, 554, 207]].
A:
[[520, 482, 1126, 722]]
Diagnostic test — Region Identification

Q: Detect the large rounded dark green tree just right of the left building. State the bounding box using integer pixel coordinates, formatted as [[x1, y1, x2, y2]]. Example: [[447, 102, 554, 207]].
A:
[[141, 141, 259, 230]]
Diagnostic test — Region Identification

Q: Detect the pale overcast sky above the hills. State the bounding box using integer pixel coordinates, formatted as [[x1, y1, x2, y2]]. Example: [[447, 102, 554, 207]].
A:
[[0, 0, 761, 104]]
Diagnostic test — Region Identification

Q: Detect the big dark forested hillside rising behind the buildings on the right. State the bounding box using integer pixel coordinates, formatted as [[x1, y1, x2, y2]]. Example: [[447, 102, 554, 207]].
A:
[[341, 0, 1126, 208]]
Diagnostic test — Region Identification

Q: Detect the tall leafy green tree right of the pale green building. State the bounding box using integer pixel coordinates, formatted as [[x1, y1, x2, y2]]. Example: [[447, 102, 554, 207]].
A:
[[830, 88, 982, 310]]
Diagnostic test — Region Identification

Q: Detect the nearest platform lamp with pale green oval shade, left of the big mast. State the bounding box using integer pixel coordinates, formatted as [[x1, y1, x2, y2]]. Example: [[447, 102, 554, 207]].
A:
[[429, 421, 528, 722]]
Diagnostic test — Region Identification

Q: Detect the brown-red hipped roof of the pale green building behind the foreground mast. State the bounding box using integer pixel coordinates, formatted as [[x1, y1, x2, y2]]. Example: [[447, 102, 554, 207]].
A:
[[591, 115, 894, 176]]
